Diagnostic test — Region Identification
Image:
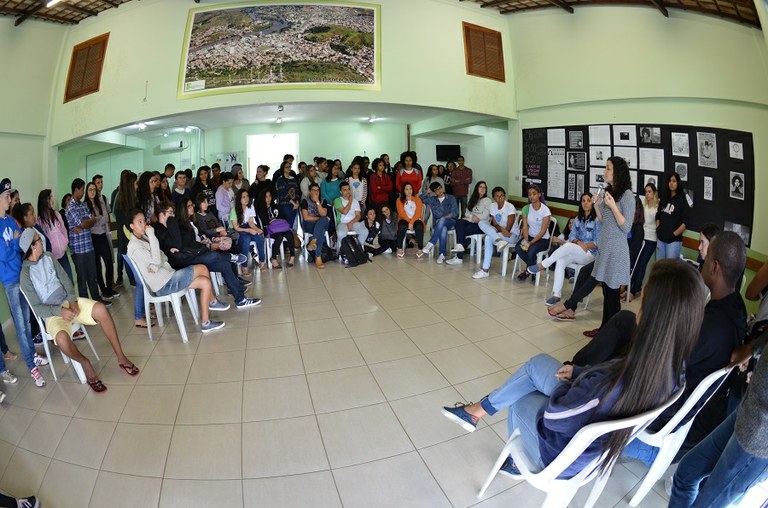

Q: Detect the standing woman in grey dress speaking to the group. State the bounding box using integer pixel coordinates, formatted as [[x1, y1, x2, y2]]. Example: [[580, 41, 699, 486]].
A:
[[549, 157, 635, 330]]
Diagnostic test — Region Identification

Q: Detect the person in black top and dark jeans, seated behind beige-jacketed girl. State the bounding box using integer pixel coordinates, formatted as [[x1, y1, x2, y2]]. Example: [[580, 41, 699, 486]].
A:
[[155, 201, 261, 309]]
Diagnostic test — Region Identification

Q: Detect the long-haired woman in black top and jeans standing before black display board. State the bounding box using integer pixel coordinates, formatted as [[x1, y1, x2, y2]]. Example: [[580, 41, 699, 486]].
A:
[[656, 173, 689, 259]]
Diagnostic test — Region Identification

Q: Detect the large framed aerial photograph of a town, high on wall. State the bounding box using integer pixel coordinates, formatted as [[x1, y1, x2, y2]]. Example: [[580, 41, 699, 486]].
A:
[[179, 3, 381, 98]]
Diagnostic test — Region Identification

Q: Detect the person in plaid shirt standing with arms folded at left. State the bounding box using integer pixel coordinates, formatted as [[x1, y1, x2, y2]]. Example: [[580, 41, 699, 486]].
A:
[[66, 178, 112, 307]]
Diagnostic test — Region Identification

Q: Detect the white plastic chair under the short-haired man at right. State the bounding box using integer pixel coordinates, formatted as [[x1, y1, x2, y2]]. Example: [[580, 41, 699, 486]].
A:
[[629, 366, 733, 506]]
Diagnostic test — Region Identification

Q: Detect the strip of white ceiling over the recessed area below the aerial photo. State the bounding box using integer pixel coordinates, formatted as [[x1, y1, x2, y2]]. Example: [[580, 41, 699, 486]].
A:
[[105, 102, 502, 137]]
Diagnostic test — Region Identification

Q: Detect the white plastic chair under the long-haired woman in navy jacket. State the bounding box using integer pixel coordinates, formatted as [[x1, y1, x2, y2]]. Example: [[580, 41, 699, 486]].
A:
[[477, 386, 685, 508]]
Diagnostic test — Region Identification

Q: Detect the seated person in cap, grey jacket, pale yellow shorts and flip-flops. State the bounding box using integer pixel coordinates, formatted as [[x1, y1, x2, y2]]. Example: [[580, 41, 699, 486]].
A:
[[19, 228, 139, 392]]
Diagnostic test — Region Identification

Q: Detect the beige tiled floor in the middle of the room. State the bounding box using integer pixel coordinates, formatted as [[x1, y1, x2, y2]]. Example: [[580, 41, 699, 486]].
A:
[[0, 256, 756, 508]]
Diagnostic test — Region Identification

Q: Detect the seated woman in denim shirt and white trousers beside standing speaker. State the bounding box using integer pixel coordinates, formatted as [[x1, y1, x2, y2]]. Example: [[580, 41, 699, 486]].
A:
[[527, 192, 600, 306]]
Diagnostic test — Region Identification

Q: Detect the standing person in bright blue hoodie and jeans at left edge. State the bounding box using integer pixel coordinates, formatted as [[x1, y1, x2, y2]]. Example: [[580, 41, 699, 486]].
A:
[[0, 178, 48, 386]]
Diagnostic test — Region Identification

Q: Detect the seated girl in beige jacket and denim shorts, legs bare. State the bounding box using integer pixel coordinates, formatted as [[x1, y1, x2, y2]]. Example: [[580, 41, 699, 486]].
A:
[[127, 210, 229, 333]]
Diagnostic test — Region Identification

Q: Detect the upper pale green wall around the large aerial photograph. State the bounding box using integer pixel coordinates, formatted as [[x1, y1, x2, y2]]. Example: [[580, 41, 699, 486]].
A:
[[48, 0, 515, 144]]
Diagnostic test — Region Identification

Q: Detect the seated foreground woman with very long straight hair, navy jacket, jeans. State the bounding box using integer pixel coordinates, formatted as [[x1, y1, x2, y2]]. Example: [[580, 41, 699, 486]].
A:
[[443, 260, 706, 478]]
